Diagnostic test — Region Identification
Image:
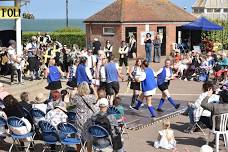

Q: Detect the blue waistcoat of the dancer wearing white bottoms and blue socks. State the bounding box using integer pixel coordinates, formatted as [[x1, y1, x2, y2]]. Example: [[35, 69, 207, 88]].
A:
[[141, 68, 157, 92]]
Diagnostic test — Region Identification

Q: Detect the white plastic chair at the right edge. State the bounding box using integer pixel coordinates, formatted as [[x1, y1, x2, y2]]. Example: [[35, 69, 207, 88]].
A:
[[207, 113, 228, 152]]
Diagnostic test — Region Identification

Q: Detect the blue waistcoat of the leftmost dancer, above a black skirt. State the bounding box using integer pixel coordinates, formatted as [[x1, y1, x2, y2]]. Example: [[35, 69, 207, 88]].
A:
[[47, 66, 61, 83]]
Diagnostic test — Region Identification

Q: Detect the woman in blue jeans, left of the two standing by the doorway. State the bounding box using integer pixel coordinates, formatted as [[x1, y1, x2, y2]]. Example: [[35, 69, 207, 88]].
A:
[[144, 33, 152, 63]]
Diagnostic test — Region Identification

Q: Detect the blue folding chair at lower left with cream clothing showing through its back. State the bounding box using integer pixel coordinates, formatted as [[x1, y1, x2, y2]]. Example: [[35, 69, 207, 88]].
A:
[[7, 116, 35, 152]]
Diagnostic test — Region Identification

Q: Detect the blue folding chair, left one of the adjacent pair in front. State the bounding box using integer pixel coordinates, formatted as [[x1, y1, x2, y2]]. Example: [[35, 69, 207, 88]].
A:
[[38, 120, 59, 152]]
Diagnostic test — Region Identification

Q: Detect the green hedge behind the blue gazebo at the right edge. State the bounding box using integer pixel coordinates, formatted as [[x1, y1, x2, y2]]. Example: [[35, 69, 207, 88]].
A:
[[202, 20, 228, 50]]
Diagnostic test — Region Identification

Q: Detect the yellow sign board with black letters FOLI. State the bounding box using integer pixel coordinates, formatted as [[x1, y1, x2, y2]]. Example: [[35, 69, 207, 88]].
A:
[[0, 6, 21, 19]]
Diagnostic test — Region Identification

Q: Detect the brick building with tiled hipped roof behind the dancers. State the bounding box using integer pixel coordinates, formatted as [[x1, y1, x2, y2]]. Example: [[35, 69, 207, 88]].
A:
[[84, 0, 195, 57]]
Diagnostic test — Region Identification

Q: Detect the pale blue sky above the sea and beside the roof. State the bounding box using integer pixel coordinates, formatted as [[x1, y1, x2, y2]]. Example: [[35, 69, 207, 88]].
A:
[[0, 0, 195, 19]]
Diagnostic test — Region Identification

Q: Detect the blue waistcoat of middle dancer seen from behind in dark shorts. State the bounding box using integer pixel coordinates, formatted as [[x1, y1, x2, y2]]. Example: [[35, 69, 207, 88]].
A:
[[105, 63, 118, 83]]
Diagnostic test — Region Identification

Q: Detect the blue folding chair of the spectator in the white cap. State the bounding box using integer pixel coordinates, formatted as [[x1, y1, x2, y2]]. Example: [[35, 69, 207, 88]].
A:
[[88, 125, 112, 151]]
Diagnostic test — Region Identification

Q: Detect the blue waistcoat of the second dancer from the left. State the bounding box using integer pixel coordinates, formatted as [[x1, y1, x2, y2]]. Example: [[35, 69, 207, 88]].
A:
[[76, 64, 91, 85]]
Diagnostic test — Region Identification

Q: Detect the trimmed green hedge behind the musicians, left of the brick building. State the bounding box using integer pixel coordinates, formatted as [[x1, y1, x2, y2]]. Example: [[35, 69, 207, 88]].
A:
[[22, 31, 86, 48]]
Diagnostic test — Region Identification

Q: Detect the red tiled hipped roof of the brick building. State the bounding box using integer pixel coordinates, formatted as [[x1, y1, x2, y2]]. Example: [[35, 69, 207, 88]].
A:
[[85, 0, 196, 23]]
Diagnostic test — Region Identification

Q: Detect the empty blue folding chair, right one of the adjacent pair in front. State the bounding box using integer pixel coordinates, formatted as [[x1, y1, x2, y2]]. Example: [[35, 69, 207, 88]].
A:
[[57, 122, 84, 151]]
